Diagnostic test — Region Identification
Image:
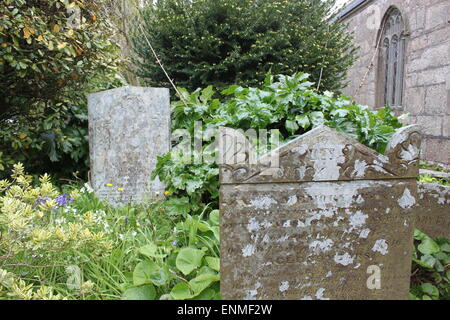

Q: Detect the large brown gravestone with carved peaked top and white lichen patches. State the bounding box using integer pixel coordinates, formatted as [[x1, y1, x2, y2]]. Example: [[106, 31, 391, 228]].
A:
[[219, 126, 421, 299]]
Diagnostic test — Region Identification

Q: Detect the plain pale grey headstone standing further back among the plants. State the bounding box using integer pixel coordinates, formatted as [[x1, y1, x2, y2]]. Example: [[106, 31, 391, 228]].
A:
[[88, 87, 170, 205]]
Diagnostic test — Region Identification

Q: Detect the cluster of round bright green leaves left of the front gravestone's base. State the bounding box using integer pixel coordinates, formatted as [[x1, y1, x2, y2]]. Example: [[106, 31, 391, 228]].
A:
[[123, 208, 220, 300]]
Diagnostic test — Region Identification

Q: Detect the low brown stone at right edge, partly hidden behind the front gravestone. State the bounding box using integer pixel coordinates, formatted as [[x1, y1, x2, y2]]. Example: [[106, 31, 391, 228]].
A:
[[416, 183, 450, 239]]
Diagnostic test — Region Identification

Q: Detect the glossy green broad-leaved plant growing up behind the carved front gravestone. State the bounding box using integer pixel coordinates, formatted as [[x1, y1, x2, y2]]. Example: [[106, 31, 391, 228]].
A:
[[153, 73, 402, 207]]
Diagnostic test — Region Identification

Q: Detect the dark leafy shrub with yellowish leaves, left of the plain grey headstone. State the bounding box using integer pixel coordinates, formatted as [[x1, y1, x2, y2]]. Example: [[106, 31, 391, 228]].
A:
[[0, 0, 124, 177]]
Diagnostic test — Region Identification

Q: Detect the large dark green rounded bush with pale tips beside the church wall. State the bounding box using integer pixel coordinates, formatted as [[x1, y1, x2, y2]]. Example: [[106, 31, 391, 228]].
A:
[[132, 0, 356, 91]]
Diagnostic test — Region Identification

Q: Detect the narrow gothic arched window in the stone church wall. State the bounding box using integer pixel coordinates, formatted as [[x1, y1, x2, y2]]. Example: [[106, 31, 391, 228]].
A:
[[379, 8, 406, 106]]
